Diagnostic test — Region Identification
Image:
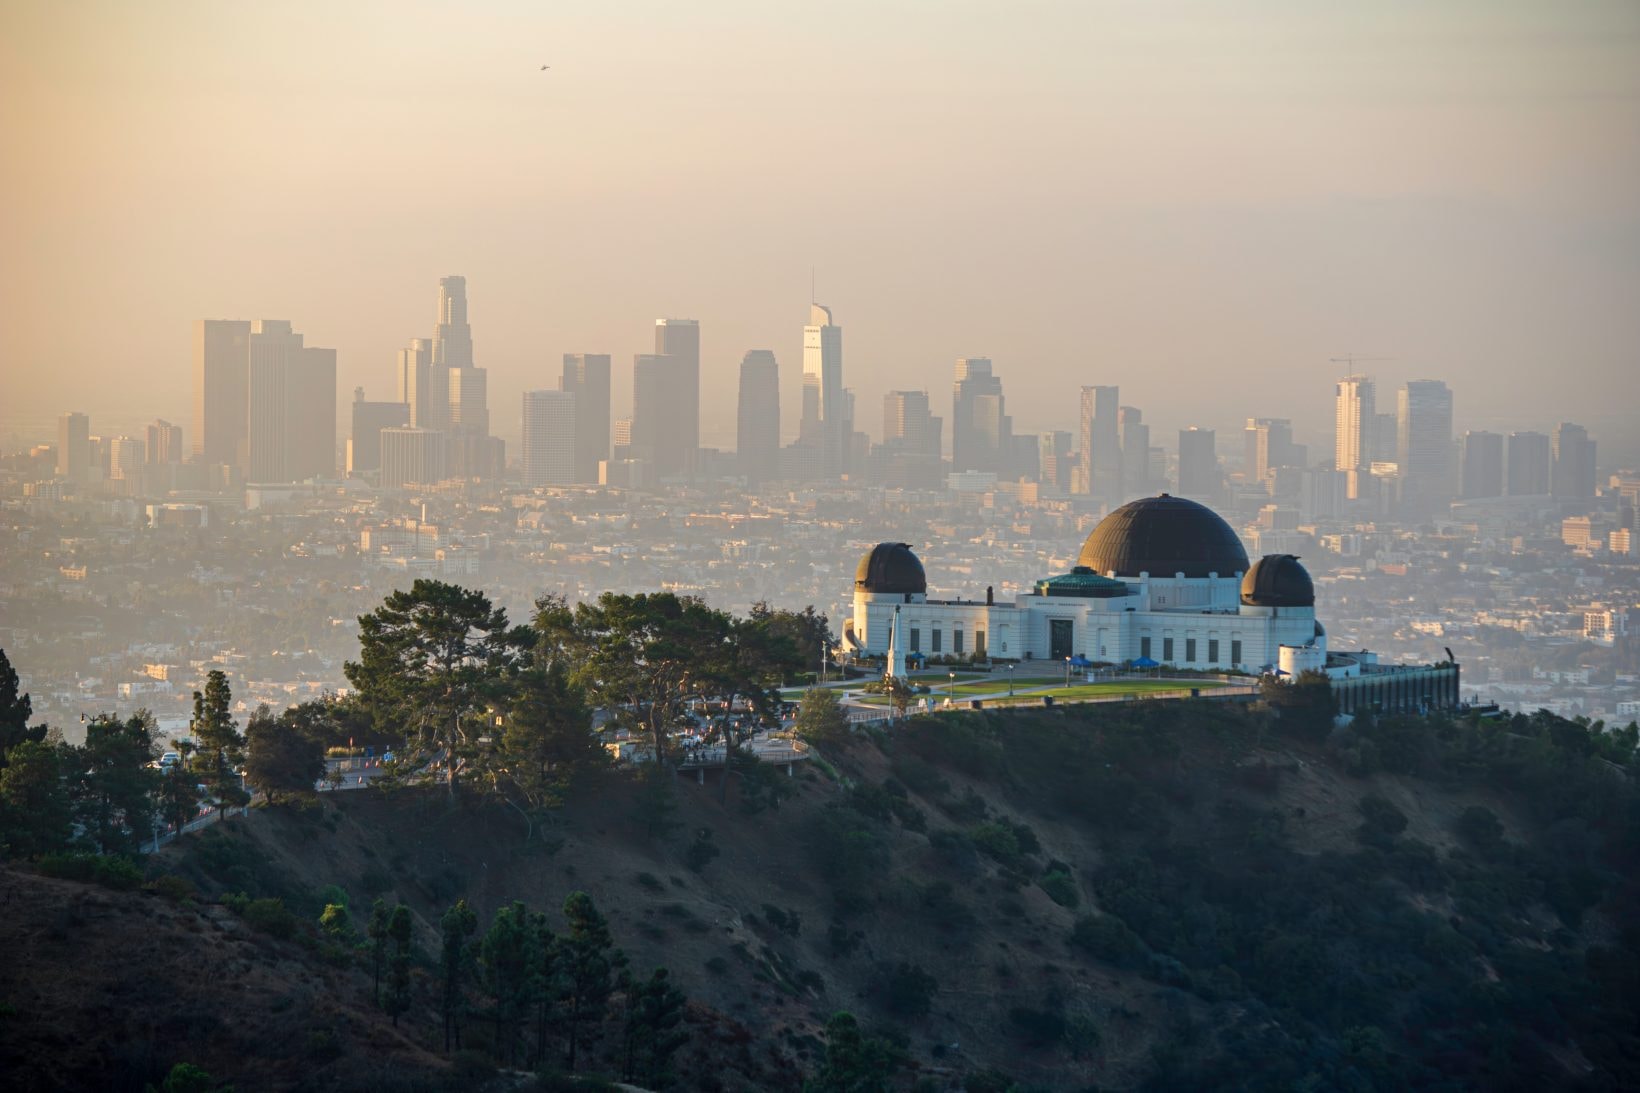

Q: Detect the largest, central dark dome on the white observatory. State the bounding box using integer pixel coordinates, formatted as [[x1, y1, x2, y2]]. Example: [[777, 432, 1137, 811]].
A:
[[1077, 494, 1246, 578]]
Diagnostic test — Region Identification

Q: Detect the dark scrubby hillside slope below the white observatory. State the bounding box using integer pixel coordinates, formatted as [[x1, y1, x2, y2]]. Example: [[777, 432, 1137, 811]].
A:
[[0, 702, 1640, 1091]]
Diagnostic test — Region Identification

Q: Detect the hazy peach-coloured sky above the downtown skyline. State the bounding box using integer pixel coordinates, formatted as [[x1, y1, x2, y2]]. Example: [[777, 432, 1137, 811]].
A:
[[0, 0, 1640, 463]]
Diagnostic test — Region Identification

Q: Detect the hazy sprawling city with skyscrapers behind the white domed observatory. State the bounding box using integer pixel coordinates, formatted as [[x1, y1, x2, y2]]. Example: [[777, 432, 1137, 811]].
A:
[[0, 276, 1640, 732]]
